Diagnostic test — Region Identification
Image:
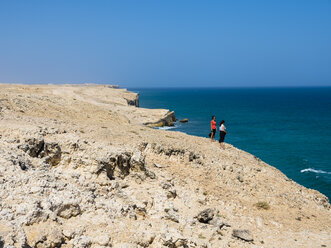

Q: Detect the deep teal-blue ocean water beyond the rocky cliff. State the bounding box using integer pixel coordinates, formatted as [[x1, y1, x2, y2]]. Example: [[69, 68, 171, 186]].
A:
[[129, 87, 331, 198]]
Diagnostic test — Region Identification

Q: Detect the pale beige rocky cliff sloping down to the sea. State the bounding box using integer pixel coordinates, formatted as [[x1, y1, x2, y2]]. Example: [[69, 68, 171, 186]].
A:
[[0, 85, 331, 248]]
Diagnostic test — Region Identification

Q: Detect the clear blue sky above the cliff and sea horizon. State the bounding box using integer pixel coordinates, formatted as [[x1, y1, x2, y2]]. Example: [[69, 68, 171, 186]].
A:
[[0, 0, 331, 87]]
